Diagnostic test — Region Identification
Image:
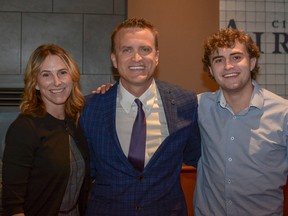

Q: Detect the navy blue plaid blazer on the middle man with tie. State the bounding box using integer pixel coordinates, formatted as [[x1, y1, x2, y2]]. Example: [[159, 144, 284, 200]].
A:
[[80, 80, 201, 216]]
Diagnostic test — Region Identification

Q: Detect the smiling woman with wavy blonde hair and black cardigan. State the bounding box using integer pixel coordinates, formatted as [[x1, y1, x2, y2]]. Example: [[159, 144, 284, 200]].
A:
[[3, 44, 89, 216]]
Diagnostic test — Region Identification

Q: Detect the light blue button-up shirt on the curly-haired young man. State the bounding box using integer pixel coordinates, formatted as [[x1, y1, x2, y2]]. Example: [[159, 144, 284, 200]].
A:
[[194, 81, 288, 216]]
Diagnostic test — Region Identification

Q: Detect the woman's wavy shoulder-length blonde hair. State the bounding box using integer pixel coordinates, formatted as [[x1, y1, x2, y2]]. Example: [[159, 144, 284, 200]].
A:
[[20, 44, 84, 123]]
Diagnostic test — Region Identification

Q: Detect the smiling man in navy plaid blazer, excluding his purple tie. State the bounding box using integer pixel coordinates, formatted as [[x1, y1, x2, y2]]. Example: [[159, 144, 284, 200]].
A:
[[80, 18, 201, 216]]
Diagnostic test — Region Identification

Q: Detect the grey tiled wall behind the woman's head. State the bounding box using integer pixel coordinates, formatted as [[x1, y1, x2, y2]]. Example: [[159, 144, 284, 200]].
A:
[[0, 0, 127, 94]]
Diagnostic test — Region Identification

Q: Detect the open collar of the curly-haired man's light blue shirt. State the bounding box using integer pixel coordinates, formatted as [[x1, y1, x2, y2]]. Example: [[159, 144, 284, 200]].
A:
[[217, 80, 264, 109]]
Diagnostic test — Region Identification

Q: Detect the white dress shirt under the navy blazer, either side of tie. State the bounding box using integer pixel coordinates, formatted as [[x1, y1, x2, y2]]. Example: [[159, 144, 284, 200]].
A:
[[116, 80, 169, 166]]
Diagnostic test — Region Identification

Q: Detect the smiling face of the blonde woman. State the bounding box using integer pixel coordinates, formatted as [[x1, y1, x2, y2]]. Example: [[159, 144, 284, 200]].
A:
[[35, 55, 73, 114]]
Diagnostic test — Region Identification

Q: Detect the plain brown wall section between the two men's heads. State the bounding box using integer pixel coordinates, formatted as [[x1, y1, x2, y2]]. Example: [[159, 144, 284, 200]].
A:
[[128, 0, 219, 93]]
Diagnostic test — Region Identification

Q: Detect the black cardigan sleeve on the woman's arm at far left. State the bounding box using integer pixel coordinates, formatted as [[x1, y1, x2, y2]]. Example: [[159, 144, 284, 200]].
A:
[[2, 118, 39, 215]]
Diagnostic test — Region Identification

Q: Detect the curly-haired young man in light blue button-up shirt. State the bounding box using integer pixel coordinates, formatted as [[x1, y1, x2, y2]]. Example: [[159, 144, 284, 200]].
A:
[[194, 29, 288, 216]]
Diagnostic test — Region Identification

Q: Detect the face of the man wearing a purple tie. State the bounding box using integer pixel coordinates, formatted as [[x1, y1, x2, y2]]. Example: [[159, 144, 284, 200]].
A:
[[111, 28, 159, 96]]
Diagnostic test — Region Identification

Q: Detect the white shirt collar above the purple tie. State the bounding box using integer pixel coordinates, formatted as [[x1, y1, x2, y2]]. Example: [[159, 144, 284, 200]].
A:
[[118, 79, 157, 113]]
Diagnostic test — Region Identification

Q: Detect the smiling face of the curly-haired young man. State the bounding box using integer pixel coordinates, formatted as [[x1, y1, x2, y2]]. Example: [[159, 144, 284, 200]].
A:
[[210, 41, 256, 93]]
